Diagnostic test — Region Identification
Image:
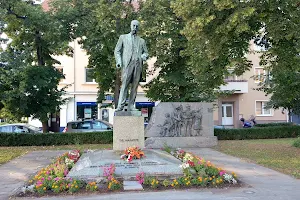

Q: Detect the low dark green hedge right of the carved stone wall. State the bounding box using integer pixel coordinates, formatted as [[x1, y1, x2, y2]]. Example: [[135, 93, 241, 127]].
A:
[[214, 126, 300, 140]]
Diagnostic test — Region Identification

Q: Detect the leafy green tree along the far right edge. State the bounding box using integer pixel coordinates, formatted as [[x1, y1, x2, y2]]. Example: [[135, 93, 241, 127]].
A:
[[257, 0, 300, 121]]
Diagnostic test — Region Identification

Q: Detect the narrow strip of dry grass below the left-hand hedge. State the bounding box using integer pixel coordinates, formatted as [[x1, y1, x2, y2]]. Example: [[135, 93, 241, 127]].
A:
[[0, 144, 112, 165]]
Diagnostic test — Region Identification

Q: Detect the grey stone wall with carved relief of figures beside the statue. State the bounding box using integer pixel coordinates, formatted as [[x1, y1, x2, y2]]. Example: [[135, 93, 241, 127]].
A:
[[145, 102, 217, 148]]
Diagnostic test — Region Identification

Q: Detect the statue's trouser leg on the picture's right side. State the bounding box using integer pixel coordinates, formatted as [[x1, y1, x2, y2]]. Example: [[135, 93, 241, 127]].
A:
[[128, 63, 142, 110]]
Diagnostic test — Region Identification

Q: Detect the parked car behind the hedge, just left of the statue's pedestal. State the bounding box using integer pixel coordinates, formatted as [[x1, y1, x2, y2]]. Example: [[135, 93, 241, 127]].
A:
[[63, 119, 113, 133]]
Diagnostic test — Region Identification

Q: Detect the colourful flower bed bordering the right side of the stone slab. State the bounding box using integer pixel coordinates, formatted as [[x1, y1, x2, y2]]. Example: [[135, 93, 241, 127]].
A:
[[141, 149, 239, 189]]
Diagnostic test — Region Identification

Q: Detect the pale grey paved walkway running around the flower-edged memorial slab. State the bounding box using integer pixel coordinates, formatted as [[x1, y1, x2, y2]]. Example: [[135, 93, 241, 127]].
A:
[[0, 148, 300, 200]]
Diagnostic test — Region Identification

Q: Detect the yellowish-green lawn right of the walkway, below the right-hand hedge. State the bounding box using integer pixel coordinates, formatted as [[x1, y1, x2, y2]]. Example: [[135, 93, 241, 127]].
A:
[[215, 138, 300, 179]]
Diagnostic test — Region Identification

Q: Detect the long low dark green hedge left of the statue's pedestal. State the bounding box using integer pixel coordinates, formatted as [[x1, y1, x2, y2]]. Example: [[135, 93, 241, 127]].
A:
[[0, 131, 113, 146]]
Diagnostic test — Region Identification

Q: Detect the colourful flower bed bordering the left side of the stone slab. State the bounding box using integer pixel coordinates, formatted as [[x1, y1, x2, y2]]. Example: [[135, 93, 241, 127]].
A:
[[17, 150, 122, 196]]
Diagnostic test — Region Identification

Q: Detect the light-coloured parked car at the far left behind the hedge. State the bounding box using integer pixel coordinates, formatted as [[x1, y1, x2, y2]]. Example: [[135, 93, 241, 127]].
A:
[[0, 123, 42, 133]]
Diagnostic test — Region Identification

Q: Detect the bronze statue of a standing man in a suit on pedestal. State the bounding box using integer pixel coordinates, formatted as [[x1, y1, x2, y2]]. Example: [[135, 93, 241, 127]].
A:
[[115, 20, 148, 111]]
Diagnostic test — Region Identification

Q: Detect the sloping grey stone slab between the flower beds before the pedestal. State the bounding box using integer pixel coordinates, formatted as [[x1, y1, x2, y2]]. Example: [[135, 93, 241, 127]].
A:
[[68, 149, 183, 179]]
